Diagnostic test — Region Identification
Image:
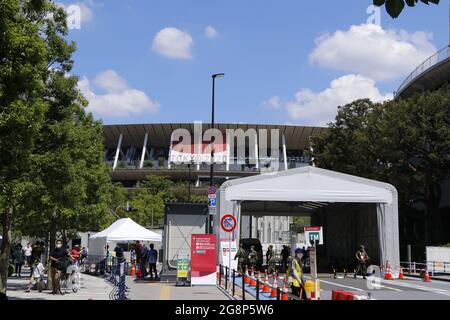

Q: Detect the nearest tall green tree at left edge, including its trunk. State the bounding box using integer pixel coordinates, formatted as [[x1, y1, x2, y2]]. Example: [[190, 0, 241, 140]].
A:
[[0, 0, 59, 292]]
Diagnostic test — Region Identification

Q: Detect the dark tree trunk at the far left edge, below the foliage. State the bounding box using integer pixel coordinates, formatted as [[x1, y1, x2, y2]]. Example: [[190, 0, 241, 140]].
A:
[[0, 207, 14, 294]]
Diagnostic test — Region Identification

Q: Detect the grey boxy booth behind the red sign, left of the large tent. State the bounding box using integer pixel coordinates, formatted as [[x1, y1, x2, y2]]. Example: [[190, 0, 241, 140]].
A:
[[160, 202, 208, 282]]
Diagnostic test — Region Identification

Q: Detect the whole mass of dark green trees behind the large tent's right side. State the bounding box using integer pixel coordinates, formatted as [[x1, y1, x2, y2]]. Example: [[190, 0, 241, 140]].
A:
[[312, 87, 450, 248]]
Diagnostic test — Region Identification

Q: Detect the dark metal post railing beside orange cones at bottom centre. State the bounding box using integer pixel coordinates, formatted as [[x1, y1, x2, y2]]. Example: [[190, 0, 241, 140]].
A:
[[217, 265, 301, 300]]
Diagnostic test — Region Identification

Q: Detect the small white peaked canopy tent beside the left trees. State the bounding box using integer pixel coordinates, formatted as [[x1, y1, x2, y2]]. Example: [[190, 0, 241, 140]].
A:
[[89, 218, 162, 256]]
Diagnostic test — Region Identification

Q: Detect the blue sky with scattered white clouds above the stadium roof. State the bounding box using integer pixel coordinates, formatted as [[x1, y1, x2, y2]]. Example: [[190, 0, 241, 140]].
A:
[[61, 0, 448, 125]]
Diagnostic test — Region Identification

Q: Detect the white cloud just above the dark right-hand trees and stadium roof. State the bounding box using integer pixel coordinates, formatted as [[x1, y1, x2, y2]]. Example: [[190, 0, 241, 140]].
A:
[[283, 74, 392, 125]]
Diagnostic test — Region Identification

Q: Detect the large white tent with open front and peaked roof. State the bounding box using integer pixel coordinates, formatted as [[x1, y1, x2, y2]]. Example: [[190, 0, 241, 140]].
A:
[[215, 167, 400, 275]]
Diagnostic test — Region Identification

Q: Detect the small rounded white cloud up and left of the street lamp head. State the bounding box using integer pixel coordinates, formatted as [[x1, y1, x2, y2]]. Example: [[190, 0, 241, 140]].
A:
[[152, 28, 194, 59]]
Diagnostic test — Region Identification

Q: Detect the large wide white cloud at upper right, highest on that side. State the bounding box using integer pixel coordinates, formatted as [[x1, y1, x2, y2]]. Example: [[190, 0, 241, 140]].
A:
[[310, 24, 436, 80]]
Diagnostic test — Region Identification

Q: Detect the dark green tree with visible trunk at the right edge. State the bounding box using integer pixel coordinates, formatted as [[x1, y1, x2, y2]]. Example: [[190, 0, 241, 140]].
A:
[[375, 87, 450, 245]]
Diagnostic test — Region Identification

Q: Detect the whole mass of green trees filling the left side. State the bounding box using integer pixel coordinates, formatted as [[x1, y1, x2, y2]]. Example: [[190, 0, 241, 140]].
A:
[[0, 0, 110, 292]]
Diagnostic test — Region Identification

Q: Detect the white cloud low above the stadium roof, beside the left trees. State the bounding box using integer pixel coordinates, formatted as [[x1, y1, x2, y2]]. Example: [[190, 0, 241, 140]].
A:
[[78, 70, 160, 118]]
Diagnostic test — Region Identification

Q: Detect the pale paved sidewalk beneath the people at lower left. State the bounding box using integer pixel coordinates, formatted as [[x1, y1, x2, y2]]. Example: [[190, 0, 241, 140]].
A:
[[7, 269, 113, 300]]
